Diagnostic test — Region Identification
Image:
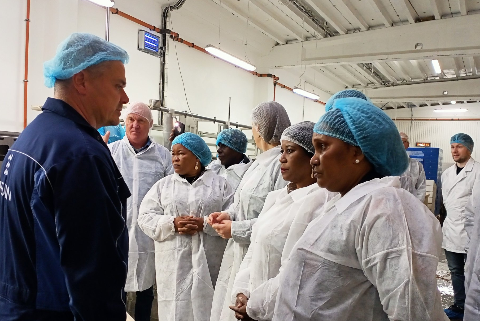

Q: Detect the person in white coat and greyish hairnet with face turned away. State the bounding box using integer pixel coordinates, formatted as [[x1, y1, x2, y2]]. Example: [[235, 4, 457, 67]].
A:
[[209, 101, 290, 321]]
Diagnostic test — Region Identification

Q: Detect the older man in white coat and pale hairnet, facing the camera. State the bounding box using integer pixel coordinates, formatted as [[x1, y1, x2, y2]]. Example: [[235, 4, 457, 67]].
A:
[[108, 102, 173, 321]]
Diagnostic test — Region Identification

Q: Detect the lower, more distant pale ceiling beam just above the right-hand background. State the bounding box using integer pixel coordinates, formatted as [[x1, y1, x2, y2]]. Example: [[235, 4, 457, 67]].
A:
[[365, 78, 480, 103]]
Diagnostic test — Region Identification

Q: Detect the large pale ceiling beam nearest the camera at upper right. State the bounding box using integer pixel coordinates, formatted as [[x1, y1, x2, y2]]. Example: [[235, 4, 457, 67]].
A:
[[261, 15, 480, 68]]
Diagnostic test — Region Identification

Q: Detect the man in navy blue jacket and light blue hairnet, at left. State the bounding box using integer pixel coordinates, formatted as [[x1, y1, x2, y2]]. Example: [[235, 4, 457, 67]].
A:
[[0, 34, 130, 321]]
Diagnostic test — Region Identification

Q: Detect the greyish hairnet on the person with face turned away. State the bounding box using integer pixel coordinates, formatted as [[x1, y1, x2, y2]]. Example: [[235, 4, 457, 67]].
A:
[[252, 101, 291, 144]]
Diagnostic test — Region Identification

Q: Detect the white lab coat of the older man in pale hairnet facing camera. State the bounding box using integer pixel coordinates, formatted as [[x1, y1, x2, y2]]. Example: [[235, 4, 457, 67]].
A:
[[108, 136, 173, 292]]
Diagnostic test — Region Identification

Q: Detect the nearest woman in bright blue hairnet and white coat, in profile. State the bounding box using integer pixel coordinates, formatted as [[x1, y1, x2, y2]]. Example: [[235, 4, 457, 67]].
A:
[[273, 98, 447, 321]]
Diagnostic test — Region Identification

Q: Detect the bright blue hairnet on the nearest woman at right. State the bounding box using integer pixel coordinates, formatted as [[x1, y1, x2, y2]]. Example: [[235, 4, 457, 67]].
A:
[[313, 98, 409, 176]]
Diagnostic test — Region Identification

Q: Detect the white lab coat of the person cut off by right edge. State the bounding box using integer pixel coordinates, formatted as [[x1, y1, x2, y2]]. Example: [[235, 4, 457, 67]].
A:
[[463, 180, 480, 321]]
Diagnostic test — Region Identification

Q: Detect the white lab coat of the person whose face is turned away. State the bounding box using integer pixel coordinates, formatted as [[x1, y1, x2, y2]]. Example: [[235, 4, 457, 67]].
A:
[[211, 146, 287, 321]]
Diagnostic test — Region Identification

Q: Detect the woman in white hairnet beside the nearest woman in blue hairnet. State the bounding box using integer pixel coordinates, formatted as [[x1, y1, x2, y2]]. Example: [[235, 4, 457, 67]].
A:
[[231, 121, 334, 320]]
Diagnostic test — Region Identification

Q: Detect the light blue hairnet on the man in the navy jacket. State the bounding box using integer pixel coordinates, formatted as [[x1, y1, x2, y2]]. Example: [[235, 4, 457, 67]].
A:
[[43, 33, 128, 88]]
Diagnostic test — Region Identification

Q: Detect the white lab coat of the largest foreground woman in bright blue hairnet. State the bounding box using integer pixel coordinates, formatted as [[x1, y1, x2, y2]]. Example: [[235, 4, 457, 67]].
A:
[[273, 177, 448, 321]]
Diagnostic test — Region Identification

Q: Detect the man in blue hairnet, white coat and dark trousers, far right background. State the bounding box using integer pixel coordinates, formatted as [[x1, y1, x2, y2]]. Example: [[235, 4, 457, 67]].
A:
[[442, 133, 480, 319]]
